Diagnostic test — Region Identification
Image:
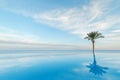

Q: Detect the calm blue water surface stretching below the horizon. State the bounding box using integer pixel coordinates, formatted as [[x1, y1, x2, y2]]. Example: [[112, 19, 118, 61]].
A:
[[0, 50, 120, 80]]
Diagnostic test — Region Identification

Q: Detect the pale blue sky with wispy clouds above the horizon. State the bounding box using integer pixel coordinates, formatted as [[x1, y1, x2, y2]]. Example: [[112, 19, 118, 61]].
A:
[[0, 0, 120, 50]]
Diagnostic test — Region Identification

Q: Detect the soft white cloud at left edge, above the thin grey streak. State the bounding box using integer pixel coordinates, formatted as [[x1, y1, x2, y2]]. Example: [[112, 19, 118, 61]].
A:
[[0, 26, 39, 43]]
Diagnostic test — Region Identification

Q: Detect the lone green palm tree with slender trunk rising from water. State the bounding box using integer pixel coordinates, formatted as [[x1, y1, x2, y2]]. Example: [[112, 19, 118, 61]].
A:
[[85, 31, 104, 58]]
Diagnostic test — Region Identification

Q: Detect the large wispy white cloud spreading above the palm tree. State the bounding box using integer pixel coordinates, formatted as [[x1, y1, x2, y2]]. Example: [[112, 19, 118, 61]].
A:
[[32, 0, 120, 36]]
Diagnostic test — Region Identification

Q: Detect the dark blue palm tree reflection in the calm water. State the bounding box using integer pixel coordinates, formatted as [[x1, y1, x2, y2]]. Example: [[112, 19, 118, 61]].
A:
[[87, 55, 108, 75]]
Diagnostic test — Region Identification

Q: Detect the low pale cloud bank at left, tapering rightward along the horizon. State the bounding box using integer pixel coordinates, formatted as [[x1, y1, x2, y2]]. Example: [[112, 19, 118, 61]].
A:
[[0, 26, 79, 50]]
